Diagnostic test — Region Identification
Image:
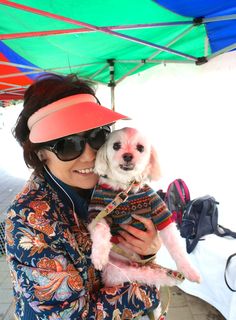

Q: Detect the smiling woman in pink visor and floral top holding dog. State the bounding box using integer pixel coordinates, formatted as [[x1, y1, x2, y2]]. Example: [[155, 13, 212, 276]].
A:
[[6, 75, 160, 320]]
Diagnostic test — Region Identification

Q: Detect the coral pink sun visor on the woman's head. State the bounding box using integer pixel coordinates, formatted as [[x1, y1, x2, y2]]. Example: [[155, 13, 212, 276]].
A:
[[28, 94, 129, 143]]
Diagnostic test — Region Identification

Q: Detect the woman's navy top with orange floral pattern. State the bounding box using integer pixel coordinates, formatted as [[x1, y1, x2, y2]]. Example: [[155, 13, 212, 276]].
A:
[[6, 172, 159, 320]]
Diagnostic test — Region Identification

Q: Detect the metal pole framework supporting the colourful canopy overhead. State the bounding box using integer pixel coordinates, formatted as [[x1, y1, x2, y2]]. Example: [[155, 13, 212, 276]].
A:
[[0, 0, 236, 109]]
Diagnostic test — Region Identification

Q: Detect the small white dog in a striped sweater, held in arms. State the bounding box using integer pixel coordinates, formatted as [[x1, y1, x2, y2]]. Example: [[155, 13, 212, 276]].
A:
[[89, 128, 200, 287]]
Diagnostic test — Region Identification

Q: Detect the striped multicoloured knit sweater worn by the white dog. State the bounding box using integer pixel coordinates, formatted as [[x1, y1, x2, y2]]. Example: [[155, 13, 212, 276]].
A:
[[88, 185, 172, 236]]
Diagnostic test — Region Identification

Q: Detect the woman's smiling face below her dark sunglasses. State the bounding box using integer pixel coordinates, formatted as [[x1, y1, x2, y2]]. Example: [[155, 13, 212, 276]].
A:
[[42, 143, 98, 189]]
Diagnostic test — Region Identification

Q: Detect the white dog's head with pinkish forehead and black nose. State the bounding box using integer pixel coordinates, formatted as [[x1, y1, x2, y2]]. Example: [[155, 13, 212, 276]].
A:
[[96, 128, 159, 183]]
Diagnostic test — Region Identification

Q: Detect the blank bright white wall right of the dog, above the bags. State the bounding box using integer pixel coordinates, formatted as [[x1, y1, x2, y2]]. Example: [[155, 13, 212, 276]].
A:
[[98, 52, 236, 230]]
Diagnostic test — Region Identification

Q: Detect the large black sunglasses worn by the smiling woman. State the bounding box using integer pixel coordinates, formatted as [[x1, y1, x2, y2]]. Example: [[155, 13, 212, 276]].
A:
[[43, 126, 111, 161]]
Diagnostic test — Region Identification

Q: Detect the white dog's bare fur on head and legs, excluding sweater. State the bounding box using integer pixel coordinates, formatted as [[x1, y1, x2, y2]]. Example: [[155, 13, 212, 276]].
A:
[[89, 127, 200, 296]]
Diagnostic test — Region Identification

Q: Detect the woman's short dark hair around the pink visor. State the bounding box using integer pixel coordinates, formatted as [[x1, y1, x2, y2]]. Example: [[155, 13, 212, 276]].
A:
[[12, 74, 97, 174]]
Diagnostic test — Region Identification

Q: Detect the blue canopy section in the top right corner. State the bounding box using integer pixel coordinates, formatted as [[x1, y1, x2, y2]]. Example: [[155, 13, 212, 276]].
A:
[[153, 0, 236, 53]]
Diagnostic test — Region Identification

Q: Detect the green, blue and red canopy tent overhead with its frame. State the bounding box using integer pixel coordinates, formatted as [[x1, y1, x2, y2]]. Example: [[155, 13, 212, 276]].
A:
[[0, 0, 236, 105]]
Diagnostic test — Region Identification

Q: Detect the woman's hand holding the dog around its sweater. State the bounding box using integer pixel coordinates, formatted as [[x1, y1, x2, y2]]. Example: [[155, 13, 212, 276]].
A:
[[116, 214, 161, 256]]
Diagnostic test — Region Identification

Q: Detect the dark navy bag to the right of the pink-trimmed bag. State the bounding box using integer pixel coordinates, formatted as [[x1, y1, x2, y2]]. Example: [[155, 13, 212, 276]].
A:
[[180, 195, 236, 253]]
